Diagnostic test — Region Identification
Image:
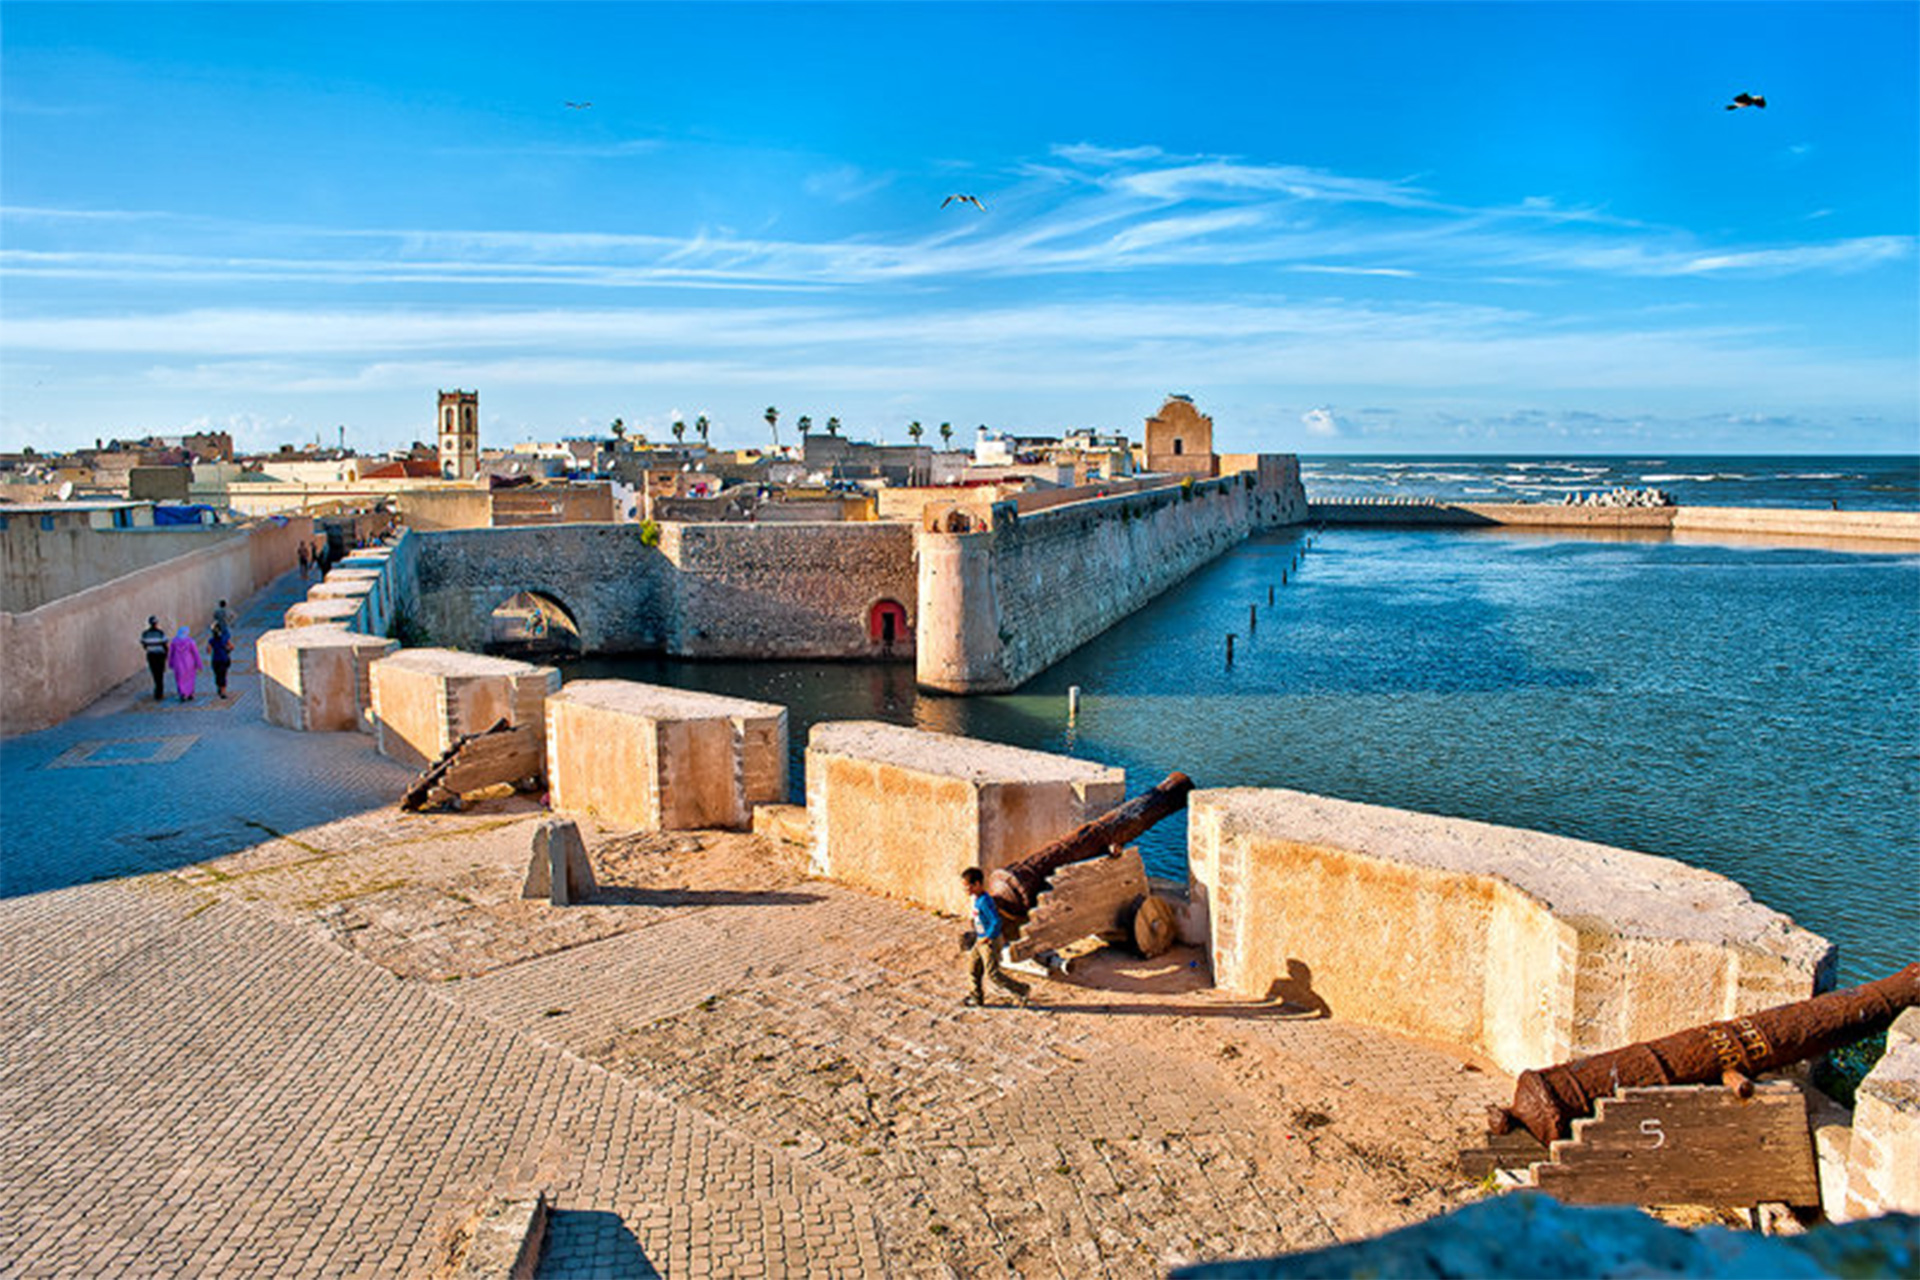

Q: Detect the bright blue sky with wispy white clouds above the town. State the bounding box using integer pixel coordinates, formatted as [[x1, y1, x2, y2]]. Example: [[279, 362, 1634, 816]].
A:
[[0, 2, 1920, 453]]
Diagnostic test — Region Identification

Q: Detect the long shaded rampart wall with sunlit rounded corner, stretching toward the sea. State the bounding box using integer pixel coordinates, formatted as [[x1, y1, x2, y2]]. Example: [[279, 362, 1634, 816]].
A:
[[916, 455, 1306, 693]]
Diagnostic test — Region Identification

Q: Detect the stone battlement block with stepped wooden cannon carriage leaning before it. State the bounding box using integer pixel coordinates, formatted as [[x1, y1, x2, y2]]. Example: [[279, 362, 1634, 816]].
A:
[[371, 649, 561, 768]]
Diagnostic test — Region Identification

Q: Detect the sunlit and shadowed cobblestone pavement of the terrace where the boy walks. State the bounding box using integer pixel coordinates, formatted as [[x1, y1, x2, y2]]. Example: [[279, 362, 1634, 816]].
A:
[[0, 578, 1507, 1276]]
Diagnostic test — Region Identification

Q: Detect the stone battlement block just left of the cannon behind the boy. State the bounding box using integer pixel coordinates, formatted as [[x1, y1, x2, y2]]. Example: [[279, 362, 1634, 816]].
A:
[[806, 722, 1127, 913]]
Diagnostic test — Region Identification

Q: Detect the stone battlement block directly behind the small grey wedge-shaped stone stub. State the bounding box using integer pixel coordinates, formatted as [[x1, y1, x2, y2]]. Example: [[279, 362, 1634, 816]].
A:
[[547, 679, 787, 831]]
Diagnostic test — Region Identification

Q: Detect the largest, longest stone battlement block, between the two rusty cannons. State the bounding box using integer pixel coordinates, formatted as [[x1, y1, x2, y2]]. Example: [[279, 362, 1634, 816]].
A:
[[1188, 789, 1834, 1071]]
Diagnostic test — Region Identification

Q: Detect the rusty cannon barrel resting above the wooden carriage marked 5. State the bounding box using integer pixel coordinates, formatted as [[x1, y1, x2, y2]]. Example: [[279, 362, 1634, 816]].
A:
[[1488, 963, 1920, 1142]]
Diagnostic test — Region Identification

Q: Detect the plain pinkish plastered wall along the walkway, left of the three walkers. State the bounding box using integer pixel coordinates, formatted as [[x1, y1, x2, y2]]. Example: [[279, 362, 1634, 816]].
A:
[[0, 516, 313, 733]]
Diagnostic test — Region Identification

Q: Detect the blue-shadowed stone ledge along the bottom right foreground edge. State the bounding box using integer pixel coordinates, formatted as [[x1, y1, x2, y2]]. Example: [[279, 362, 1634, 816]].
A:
[[1173, 1192, 1920, 1280]]
